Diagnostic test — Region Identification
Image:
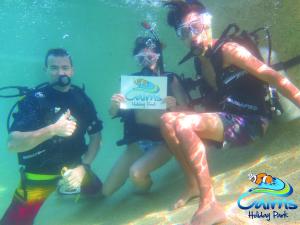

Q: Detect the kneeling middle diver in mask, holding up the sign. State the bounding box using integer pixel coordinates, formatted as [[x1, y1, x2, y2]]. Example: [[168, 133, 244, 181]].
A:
[[103, 35, 188, 196]]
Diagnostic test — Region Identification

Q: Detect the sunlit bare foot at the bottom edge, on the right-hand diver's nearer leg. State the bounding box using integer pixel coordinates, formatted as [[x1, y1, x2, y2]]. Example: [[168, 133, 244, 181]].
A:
[[190, 202, 226, 225]]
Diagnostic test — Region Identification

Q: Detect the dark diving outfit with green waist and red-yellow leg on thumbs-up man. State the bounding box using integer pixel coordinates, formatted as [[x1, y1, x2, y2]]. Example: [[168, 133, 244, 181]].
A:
[[0, 86, 102, 225]]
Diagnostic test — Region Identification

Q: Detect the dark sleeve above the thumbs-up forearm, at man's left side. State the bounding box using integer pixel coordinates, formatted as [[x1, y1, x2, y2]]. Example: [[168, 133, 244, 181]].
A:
[[9, 96, 41, 132]]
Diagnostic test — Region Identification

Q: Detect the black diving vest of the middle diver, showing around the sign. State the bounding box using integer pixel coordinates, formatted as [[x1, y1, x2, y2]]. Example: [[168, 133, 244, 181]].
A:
[[117, 68, 176, 146]]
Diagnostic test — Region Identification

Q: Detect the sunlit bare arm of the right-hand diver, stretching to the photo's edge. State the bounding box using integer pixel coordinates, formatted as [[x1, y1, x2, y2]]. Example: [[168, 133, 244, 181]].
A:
[[222, 42, 300, 108]]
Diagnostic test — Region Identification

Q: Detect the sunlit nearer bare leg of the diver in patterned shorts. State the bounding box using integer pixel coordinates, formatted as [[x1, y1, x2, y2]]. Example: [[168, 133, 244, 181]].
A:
[[163, 113, 226, 225]]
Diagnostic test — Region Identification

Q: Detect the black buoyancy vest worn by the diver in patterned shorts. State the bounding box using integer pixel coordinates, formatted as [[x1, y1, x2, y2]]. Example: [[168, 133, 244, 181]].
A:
[[195, 24, 272, 117]]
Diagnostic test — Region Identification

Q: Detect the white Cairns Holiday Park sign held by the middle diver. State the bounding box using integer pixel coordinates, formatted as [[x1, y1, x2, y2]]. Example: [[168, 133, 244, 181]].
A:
[[121, 76, 168, 109]]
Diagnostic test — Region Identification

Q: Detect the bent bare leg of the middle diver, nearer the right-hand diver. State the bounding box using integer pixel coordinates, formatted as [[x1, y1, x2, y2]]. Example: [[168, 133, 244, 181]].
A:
[[130, 144, 172, 193]]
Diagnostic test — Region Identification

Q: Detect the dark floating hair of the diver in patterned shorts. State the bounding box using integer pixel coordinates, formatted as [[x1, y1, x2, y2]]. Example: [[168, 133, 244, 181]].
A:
[[164, 0, 206, 29]]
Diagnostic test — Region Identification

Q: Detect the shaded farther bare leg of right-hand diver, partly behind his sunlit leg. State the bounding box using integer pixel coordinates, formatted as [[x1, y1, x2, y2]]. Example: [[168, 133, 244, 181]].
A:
[[162, 112, 200, 209]]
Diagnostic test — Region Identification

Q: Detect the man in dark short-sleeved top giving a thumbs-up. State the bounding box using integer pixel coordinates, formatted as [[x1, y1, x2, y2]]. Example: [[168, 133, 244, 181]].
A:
[[0, 48, 102, 225]]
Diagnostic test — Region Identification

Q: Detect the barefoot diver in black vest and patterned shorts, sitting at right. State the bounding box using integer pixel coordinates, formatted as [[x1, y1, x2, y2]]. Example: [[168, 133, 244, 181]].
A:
[[162, 0, 300, 225]]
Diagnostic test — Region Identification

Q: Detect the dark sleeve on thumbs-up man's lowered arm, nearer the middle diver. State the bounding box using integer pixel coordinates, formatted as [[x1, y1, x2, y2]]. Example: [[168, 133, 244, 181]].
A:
[[86, 96, 103, 135]]
